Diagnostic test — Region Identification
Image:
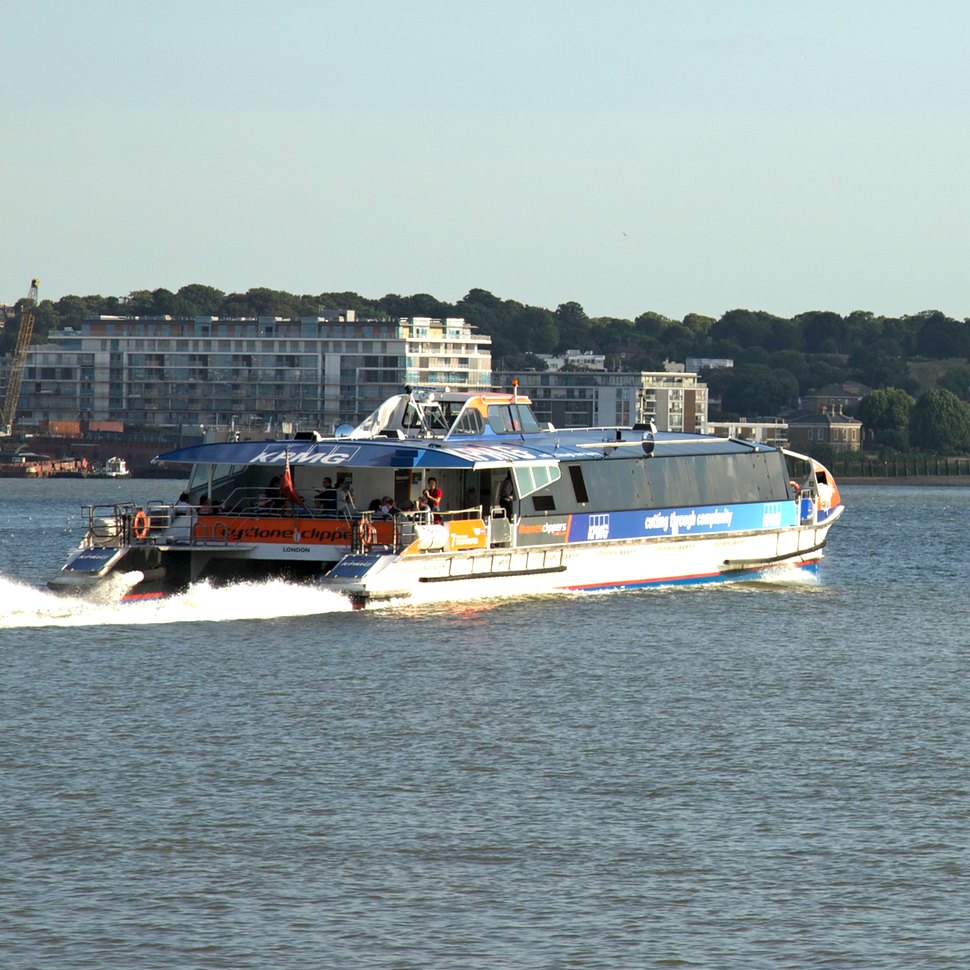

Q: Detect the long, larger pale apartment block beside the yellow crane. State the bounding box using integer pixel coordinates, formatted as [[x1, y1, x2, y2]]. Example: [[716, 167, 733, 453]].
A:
[[18, 311, 491, 433]]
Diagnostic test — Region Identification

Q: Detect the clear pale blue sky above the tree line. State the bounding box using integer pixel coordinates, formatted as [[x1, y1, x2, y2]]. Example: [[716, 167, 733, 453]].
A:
[[0, 0, 970, 319]]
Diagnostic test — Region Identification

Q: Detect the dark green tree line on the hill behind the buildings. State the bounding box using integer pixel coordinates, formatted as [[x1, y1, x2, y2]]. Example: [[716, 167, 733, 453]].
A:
[[0, 283, 970, 451]]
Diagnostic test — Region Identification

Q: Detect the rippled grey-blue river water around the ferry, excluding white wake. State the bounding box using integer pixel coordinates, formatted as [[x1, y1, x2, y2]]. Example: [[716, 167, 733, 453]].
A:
[[0, 480, 970, 970]]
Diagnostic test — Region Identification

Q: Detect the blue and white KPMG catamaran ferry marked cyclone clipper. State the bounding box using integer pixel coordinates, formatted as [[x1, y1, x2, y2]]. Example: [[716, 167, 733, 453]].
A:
[[49, 388, 843, 607]]
